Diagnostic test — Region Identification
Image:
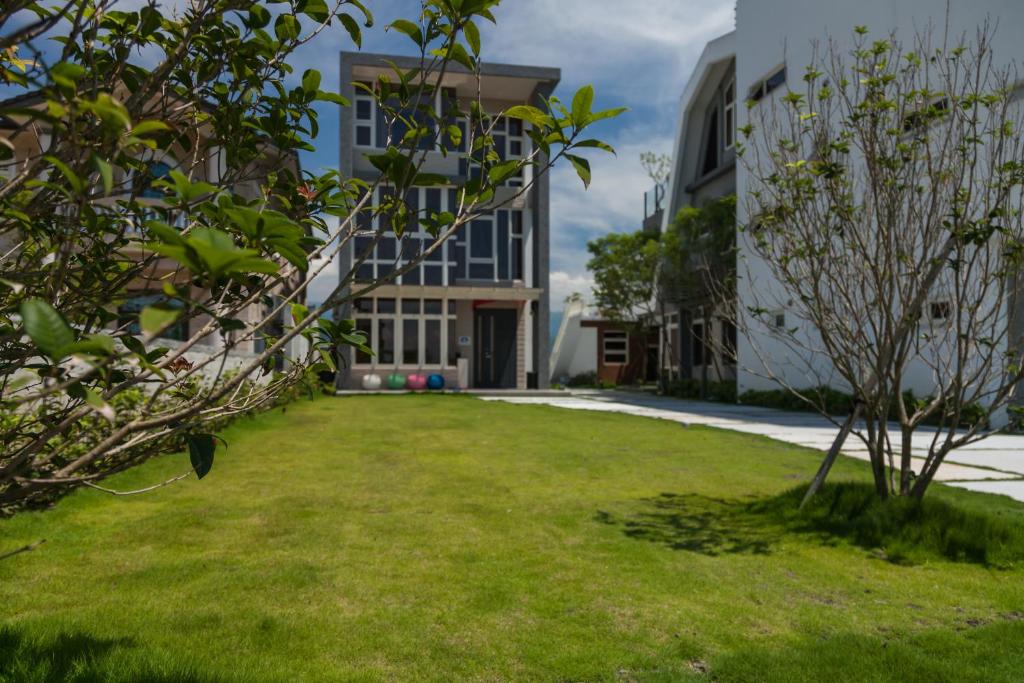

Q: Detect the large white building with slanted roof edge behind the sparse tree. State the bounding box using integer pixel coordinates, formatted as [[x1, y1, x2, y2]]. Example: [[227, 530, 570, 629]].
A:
[[662, 0, 1024, 419]]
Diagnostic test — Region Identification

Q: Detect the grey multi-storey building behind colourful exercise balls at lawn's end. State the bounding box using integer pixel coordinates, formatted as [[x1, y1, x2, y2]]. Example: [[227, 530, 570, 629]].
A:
[[338, 52, 560, 389]]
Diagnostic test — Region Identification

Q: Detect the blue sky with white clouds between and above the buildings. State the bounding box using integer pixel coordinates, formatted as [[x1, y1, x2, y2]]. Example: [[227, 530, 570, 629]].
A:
[[295, 0, 734, 311]]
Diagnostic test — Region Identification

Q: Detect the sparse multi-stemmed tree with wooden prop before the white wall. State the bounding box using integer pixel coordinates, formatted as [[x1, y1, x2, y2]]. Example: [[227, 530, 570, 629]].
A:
[[739, 27, 1024, 501]]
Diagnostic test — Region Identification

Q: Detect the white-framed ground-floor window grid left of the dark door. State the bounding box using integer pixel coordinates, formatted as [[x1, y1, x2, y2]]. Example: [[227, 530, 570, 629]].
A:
[[353, 298, 456, 369]]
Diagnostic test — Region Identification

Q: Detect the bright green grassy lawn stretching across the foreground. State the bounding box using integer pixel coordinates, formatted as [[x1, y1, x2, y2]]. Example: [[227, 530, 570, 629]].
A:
[[0, 396, 1024, 682]]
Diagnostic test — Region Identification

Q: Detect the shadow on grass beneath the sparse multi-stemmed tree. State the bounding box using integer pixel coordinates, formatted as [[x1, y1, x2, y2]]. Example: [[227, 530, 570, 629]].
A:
[[596, 483, 1024, 568]]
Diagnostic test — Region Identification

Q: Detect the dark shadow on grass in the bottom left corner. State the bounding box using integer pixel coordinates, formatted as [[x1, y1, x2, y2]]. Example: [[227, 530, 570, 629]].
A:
[[0, 626, 217, 683]]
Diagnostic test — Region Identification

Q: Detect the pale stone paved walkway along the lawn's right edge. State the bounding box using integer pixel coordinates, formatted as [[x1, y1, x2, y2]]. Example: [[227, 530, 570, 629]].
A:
[[481, 390, 1024, 501]]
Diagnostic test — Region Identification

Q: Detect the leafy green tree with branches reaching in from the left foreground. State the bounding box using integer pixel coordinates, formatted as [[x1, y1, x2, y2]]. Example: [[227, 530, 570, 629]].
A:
[[0, 0, 622, 513]]
